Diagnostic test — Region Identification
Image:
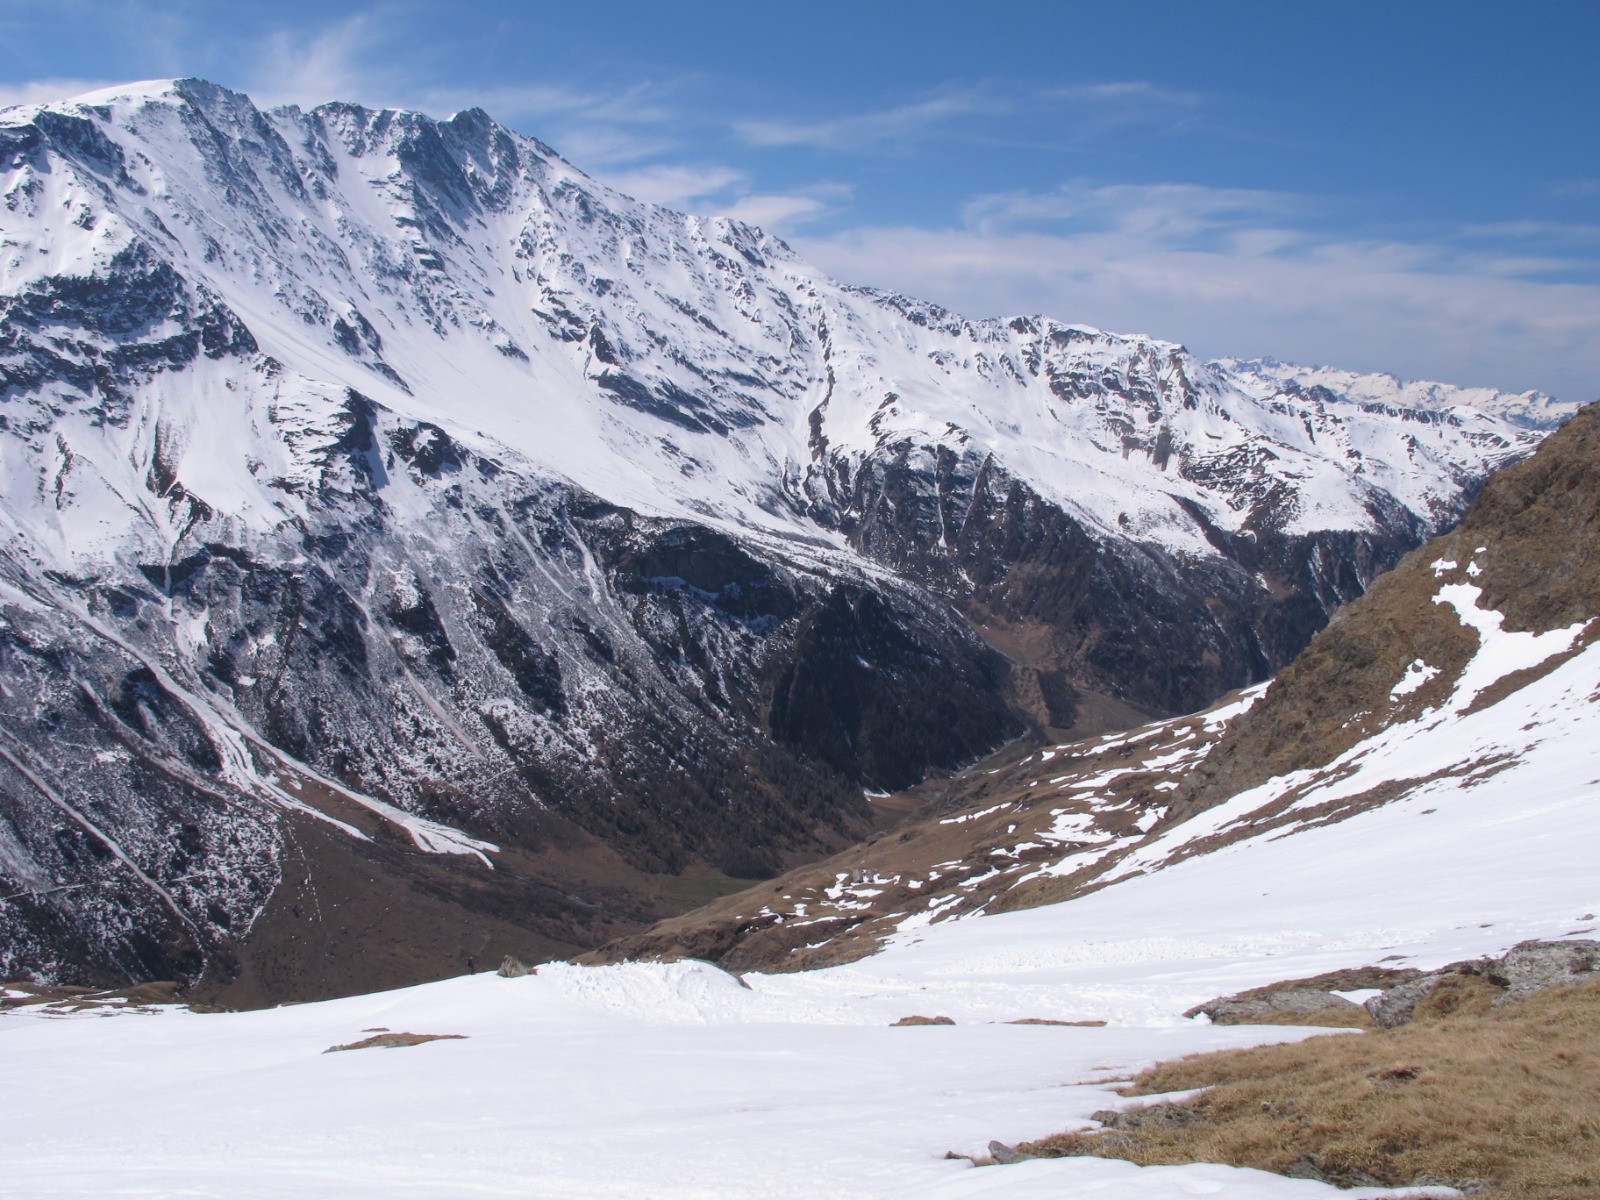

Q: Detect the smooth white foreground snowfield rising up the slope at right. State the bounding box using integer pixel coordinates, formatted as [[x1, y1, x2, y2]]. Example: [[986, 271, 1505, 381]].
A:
[[0, 630, 1600, 1200]]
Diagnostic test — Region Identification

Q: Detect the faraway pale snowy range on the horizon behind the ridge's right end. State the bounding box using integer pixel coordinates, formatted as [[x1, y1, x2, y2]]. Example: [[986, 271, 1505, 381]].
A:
[[1213, 358, 1582, 429]]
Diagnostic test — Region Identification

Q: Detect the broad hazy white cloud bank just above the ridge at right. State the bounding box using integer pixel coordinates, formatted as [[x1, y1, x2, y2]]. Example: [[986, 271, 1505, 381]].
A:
[[797, 184, 1600, 400]]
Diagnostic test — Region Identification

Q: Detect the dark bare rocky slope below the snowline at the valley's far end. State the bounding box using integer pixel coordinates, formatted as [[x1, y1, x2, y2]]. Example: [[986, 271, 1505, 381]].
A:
[[814, 446, 1422, 725]]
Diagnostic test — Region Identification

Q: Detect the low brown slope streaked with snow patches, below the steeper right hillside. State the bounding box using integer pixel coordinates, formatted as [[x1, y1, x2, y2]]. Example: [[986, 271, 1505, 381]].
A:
[[578, 714, 1216, 971]]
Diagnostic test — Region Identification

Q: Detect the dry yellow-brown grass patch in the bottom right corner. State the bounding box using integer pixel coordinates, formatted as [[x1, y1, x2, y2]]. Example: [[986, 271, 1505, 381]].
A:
[[1018, 981, 1600, 1200]]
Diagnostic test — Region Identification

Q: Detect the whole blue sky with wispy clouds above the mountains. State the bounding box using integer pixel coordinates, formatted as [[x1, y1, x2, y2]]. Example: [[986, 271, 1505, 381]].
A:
[[0, 0, 1600, 400]]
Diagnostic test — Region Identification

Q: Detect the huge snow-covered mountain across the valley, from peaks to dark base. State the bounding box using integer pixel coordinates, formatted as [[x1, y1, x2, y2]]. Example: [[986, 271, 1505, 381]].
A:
[[0, 80, 1539, 998]]
